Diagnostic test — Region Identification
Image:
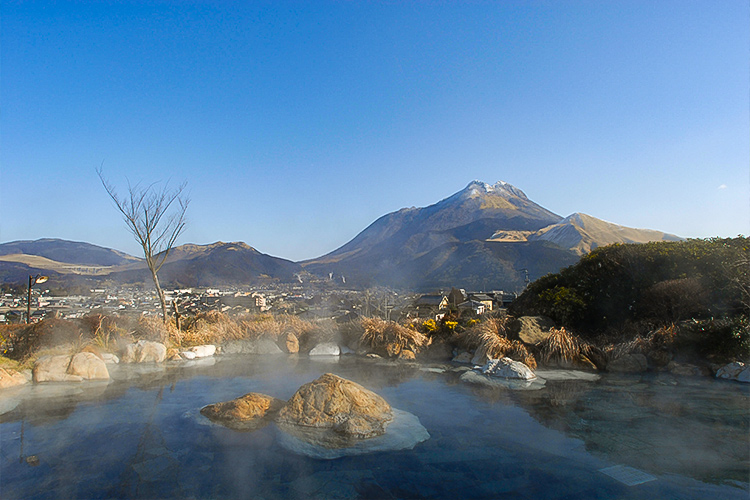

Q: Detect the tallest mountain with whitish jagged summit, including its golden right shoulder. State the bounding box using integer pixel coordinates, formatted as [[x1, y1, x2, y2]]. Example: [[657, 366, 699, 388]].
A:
[[301, 181, 677, 290]]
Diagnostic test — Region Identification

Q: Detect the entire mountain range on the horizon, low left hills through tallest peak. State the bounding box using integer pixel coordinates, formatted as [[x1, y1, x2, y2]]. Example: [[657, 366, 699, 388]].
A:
[[0, 181, 679, 290]]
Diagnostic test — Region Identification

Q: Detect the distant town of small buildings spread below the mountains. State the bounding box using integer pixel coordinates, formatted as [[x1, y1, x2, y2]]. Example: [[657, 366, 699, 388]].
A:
[[0, 284, 517, 324]]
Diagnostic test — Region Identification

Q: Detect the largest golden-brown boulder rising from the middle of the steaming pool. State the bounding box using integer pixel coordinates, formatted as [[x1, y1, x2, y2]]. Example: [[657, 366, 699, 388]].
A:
[[276, 373, 393, 439]]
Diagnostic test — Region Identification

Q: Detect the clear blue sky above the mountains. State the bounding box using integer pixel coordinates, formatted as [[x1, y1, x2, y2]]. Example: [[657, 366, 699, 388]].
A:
[[0, 0, 750, 260]]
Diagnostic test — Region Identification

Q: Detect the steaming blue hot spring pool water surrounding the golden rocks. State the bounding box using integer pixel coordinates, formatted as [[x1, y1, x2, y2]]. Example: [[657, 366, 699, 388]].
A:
[[0, 357, 750, 500]]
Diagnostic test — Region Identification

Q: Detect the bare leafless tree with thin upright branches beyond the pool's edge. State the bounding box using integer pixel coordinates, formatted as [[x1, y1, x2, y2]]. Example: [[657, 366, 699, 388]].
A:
[[96, 167, 190, 323]]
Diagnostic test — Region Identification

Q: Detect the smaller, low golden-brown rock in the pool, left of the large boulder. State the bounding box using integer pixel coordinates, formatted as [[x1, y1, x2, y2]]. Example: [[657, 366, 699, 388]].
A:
[[201, 392, 285, 430]]
